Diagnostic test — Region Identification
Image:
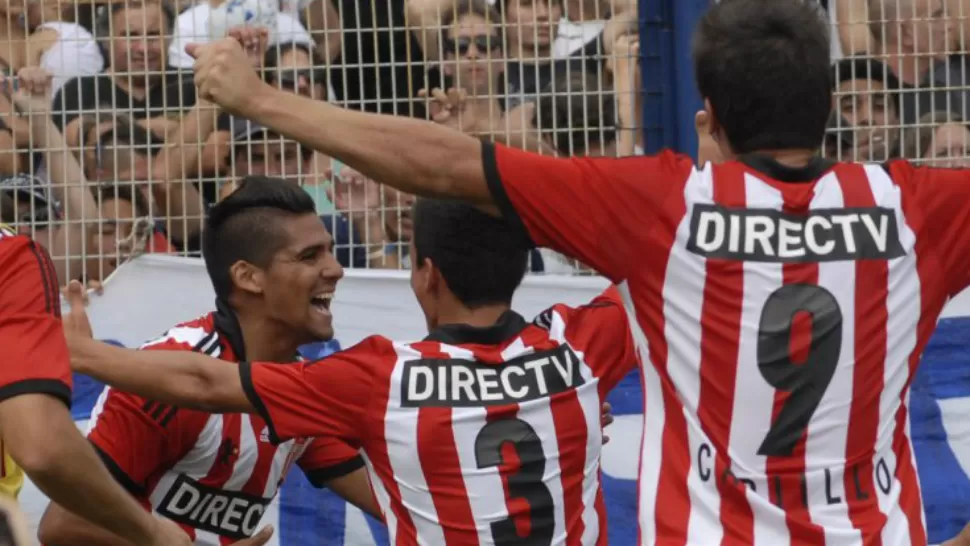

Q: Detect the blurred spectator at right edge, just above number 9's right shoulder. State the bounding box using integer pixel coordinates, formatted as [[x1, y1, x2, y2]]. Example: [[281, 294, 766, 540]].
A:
[[892, 110, 970, 164]]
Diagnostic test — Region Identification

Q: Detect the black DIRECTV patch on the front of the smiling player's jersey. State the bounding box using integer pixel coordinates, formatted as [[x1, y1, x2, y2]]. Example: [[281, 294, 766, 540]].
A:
[[157, 474, 271, 539]]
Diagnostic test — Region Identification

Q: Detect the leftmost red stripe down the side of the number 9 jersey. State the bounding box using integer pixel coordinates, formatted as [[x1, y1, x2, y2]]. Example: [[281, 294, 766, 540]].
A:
[[644, 169, 697, 546]]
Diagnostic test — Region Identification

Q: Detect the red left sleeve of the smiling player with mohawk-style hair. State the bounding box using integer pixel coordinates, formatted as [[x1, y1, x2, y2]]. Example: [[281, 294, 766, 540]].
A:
[[88, 388, 199, 497]]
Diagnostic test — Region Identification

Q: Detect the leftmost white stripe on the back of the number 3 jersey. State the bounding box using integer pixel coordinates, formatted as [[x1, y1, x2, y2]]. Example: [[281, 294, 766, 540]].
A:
[[384, 343, 445, 546]]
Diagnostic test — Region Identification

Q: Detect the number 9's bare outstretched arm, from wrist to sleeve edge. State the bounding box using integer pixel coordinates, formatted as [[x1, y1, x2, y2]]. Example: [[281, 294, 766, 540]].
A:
[[249, 85, 499, 216]]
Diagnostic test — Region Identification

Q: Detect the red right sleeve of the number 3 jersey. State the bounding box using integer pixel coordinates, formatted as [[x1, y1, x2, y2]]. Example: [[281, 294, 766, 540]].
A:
[[536, 286, 638, 397]]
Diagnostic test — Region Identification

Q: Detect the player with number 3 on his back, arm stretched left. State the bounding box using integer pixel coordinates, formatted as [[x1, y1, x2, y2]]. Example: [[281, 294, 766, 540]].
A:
[[62, 200, 636, 546]]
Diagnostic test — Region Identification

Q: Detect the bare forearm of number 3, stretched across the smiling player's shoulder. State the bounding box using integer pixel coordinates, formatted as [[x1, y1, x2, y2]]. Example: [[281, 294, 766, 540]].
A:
[[68, 335, 256, 413]]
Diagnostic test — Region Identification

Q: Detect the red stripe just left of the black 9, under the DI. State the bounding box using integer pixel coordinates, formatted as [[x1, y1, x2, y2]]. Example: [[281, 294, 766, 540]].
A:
[[697, 163, 754, 546]]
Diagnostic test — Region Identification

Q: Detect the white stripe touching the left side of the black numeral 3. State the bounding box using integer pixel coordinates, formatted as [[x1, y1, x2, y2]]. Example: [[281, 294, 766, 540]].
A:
[[441, 343, 500, 545]]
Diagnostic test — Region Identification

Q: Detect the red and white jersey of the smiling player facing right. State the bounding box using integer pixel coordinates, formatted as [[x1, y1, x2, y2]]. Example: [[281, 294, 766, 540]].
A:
[[88, 310, 363, 545]]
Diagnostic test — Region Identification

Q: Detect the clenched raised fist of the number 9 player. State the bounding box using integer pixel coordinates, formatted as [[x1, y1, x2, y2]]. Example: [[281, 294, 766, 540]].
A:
[[185, 28, 273, 117]]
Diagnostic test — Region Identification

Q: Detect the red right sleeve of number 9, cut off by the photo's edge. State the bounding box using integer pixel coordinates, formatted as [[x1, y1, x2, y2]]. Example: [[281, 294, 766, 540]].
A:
[[887, 161, 970, 296]]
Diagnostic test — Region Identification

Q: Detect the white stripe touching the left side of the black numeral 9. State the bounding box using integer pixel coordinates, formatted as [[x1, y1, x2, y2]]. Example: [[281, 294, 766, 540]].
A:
[[729, 175, 789, 546]]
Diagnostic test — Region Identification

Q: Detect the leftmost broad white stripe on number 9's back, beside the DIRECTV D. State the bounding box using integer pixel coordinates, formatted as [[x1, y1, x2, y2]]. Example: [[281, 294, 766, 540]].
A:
[[660, 169, 723, 544]]
